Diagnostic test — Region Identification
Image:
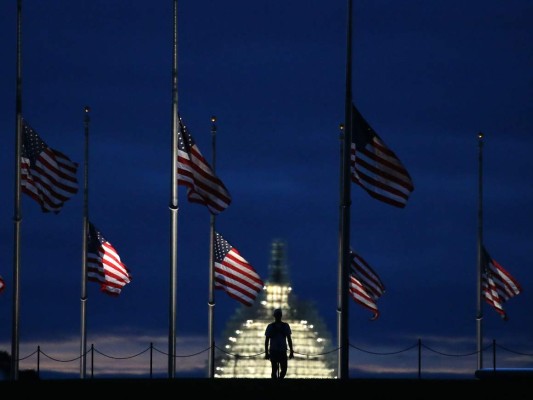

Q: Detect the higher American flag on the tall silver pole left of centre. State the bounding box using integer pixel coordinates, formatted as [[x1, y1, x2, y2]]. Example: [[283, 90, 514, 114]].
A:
[[178, 118, 231, 215]]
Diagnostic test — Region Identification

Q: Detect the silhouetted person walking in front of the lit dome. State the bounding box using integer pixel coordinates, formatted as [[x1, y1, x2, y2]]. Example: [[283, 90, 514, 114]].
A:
[[265, 308, 294, 379]]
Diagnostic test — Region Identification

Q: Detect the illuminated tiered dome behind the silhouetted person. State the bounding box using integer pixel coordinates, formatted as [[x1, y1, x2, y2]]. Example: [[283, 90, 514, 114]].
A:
[[215, 240, 337, 379]]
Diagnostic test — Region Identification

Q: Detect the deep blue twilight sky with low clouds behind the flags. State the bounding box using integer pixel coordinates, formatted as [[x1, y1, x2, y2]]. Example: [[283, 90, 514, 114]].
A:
[[0, 0, 533, 377]]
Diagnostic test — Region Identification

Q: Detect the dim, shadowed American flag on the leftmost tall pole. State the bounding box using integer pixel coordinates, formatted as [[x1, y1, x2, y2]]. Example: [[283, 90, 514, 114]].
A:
[[20, 120, 78, 214]]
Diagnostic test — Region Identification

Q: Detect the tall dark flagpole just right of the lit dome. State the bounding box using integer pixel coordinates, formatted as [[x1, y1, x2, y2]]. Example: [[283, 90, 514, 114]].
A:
[[337, 0, 352, 379]]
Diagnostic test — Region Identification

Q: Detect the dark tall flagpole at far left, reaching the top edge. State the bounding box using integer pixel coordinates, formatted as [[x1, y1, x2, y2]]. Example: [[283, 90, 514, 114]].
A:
[[11, 0, 22, 381]]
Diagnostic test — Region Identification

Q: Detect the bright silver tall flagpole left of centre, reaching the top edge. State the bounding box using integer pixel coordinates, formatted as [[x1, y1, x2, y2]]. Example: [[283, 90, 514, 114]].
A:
[[168, 0, 179, 378]]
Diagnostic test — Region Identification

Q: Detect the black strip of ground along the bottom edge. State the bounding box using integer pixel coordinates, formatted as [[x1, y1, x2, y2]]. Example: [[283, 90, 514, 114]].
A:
[[0, 377, 533, 400]]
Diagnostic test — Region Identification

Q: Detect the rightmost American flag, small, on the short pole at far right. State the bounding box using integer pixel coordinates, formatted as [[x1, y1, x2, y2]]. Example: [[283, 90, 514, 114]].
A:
[[481, 248, 522, 320]]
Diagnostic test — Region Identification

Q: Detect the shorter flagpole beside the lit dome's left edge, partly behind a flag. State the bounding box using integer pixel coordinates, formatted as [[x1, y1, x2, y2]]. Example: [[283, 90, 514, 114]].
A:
[[208, 116, 217, 378]]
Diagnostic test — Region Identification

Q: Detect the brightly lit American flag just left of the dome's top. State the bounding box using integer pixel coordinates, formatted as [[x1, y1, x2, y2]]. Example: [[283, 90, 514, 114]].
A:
[[214, 232, 264, 306]]
